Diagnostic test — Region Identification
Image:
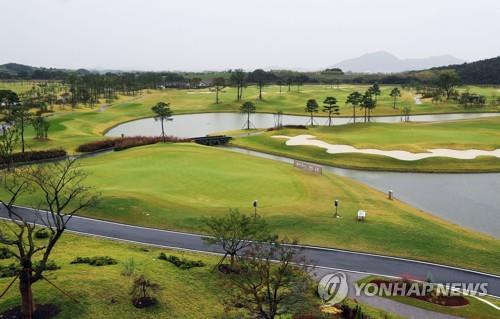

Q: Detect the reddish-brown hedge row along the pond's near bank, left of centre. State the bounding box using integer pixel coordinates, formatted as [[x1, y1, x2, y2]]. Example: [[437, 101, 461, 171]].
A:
[[76, 136, 190, 153]]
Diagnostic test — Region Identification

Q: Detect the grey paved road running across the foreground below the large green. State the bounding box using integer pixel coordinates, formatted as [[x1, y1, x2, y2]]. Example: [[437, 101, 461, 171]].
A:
[[0, 207, 500, 297]]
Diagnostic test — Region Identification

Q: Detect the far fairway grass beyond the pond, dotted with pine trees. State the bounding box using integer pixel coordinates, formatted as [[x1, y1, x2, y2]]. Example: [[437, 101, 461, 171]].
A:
[[13, 84, 497, 152]]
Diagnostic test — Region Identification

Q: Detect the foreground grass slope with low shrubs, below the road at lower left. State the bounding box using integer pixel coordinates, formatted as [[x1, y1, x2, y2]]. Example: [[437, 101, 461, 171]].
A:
[[0, 229, 240, 319]]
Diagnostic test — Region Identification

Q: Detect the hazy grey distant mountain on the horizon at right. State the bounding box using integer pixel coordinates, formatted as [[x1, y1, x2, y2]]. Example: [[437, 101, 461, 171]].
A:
[[333, 51, 464, 73]]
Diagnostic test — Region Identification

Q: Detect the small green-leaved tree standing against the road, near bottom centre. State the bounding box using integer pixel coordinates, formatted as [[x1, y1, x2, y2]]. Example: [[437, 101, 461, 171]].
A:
[[203, 210, 269, 269]]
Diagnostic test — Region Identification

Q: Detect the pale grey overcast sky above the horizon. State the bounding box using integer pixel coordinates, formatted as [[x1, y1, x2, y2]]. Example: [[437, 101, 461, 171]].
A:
[[0, 0, 500, 70]]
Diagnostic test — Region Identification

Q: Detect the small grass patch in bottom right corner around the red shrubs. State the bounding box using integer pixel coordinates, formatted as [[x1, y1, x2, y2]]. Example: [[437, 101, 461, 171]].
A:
[[358, 276, 500, 319]]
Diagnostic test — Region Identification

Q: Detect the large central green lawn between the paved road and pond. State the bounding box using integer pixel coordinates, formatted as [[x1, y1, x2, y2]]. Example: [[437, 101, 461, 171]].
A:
[[4, 144, 500, 273]]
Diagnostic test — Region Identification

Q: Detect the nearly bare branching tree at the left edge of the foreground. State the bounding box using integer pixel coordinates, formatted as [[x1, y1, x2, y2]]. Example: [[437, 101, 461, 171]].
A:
[[0, 159, 97, 319]]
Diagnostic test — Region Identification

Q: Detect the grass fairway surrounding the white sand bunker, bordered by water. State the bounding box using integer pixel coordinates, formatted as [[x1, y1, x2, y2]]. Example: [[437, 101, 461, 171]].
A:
[[231, 117, 500, 172]]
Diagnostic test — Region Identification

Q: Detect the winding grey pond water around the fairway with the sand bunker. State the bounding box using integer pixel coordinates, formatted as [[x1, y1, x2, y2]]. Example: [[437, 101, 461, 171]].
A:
[[106, 113, 500, 237]]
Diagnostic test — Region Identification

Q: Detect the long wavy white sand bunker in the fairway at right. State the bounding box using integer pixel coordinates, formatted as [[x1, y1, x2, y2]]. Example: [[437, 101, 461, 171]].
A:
[[273, 135, 500, 161]]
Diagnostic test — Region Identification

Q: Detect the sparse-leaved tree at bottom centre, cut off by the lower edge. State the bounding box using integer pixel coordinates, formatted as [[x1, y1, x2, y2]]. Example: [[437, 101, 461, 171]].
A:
[[229, 240, 312, 319]]
